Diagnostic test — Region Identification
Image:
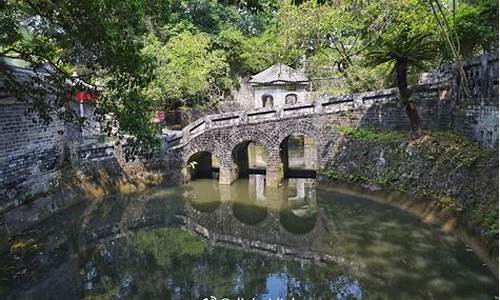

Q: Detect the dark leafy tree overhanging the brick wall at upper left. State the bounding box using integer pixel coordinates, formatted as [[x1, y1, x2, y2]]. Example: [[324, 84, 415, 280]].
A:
[[0, 0, 158, 152]]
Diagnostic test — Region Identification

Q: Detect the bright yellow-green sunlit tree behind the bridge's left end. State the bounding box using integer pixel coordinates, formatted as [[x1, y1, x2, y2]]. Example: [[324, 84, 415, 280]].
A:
[[143, 31, 231, 108]]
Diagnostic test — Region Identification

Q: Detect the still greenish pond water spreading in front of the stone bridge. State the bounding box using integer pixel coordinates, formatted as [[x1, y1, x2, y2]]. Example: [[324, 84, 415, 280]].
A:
[[0, 175, 497, 299]]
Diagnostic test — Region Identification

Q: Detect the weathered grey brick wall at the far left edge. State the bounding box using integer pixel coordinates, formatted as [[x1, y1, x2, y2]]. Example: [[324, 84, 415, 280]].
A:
[[0, 101, 64, 210]]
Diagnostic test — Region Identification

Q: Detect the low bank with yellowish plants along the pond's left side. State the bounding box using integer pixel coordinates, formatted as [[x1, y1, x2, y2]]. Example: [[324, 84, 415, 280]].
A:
[[0, 163, 167, 254]]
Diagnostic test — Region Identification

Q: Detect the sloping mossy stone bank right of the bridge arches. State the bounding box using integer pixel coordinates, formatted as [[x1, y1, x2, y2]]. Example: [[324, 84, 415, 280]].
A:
[[322, 127, 498, 270]]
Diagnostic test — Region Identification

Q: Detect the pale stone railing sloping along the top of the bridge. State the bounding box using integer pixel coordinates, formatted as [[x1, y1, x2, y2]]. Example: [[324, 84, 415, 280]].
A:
[[163, 88, 399, 149]]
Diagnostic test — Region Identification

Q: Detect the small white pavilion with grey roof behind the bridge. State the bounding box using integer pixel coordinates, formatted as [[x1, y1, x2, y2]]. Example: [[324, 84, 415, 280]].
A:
[[250, 64, 309, 109]]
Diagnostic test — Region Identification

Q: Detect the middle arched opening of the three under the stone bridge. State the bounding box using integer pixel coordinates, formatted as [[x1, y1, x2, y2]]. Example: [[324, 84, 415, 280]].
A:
[[232, 141, 267, 178]]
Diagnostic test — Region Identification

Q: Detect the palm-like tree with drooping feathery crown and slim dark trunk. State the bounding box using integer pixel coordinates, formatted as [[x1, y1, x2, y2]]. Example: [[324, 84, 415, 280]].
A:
[[368, 32, 436, 137]]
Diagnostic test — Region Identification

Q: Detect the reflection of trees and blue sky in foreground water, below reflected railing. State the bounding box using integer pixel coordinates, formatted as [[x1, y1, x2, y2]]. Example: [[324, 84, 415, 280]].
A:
[[80, 229, 362, 300]]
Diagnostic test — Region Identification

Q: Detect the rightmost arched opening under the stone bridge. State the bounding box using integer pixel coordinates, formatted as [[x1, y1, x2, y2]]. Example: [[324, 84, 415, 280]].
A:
[[280, 133, 318, 178]]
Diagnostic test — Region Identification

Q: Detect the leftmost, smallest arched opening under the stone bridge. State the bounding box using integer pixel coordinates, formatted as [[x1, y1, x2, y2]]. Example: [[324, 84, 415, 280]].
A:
[[187, 151, 219, 180]]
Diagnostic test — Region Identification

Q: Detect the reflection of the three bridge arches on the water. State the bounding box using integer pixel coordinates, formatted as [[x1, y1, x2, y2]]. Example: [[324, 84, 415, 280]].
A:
[[185, 174, 317, 234]]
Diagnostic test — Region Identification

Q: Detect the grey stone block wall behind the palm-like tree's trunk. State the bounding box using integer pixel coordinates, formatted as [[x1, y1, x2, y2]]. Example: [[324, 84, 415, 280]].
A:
[[320, 53, 499, 148]]
